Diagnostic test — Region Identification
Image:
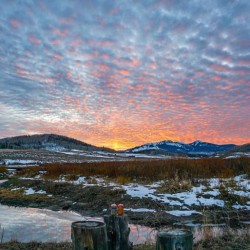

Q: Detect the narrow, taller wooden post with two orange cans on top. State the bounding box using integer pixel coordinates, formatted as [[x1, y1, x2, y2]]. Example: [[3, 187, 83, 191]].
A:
[[104, 215, 132, 250]]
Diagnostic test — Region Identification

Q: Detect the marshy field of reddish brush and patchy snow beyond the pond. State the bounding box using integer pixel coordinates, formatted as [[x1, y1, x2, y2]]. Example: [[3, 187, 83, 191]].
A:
[[0, 157, 250, 247]]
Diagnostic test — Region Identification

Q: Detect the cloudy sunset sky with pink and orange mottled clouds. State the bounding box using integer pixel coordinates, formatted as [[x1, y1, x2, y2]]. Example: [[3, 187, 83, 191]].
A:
[[0, 0, 250, 149]]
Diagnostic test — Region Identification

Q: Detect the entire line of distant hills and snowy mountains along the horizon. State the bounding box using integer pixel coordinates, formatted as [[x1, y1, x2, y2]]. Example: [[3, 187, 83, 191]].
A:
[[0, 134, 244, 157]]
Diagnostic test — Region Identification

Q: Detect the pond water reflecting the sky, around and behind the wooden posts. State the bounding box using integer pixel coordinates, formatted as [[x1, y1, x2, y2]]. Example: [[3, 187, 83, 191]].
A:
[[0, 204, 250, 245]]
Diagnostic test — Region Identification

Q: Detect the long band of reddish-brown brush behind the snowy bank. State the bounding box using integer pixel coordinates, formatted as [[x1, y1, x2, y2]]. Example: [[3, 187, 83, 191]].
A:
[[18, 157, 250, 183]]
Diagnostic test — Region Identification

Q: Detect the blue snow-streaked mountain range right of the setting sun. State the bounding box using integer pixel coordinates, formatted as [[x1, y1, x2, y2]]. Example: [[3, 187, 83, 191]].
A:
[[126, 140, 236, 156]]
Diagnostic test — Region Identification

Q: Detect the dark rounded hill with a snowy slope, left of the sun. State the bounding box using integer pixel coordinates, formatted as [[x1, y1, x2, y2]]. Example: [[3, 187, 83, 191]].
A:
[[0, 134, 112, 151]]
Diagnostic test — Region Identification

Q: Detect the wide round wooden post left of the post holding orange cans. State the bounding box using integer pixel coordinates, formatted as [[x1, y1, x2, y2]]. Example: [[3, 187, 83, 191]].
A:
[[71, 221, 108, 250]]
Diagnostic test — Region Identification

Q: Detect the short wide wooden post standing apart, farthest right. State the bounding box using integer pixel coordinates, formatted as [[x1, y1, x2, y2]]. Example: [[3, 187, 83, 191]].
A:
[[156, 229, 193, 250]]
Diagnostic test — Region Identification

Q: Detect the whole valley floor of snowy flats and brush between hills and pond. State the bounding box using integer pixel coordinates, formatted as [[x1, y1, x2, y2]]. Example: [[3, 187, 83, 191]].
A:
[[0, 135, 250, 249]]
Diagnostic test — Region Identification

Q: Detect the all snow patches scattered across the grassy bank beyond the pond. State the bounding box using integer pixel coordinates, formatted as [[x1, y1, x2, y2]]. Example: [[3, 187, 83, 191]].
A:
[[15, 173, 250, 215]]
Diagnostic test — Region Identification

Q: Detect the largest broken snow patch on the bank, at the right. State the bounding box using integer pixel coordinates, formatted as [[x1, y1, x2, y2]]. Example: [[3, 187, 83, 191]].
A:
[[122, 175, 250, 210]]
